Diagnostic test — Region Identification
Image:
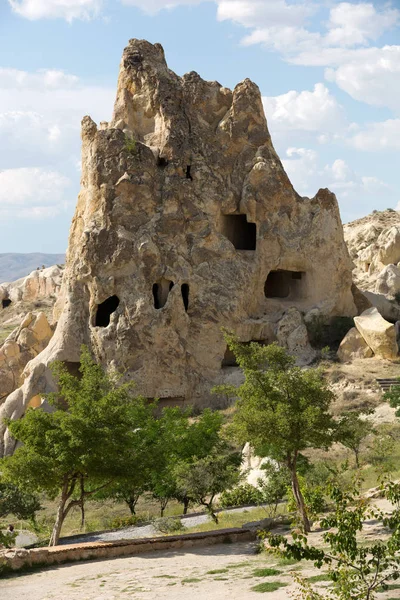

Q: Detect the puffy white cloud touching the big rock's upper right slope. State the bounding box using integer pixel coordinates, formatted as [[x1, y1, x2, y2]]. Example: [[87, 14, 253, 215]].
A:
[[263, 83, 344, 134]]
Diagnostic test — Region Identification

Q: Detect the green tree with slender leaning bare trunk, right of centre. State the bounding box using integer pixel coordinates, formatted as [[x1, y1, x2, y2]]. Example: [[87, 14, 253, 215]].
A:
[[215, 334, 335, 531]]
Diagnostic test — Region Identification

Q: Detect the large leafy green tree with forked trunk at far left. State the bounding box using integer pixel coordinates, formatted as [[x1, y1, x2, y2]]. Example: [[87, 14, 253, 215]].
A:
[[0, 347, 158, 545]]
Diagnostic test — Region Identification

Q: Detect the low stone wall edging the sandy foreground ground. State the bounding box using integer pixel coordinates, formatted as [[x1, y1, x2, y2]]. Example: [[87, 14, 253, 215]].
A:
[[0, 528, 256, 574]]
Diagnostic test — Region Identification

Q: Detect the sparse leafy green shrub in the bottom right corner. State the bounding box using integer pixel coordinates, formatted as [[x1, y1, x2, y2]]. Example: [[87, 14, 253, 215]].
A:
[[267, 482, 400, 600]]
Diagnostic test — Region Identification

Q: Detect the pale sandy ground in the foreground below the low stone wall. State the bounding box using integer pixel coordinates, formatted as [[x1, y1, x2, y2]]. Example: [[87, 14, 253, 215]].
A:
[[0, 543, 324, 600]]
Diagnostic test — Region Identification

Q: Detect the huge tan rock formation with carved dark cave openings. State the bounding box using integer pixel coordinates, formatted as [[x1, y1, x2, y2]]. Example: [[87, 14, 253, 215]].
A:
[[0, 40, 356, 453]]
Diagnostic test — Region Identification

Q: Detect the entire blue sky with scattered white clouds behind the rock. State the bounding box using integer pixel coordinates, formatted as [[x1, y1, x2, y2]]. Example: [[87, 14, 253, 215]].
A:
[[0, 0, 400, 253]]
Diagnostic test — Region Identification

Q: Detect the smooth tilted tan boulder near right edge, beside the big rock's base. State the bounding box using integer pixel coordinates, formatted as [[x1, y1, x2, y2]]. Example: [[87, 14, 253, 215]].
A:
[[354, 308, 398, 359]]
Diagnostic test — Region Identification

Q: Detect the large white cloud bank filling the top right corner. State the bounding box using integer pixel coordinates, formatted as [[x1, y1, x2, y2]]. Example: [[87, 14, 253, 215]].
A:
[[217, 0, 400, 110]]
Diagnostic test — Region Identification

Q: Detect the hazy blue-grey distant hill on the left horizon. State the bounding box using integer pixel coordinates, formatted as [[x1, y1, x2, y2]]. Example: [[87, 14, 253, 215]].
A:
[[0, 252, 65, 283]]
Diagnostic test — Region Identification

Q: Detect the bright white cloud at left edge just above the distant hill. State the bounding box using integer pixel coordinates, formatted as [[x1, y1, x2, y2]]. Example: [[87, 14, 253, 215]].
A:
[[0, 168, 71, 218]]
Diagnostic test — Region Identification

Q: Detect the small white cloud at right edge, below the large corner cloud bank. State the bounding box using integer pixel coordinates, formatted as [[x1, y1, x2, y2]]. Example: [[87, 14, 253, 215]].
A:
[[348, 119, 400, 152]]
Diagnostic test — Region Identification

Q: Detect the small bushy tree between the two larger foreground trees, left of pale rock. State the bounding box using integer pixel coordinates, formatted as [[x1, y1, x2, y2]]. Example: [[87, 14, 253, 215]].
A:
[[175, 443, 242, 523]]
